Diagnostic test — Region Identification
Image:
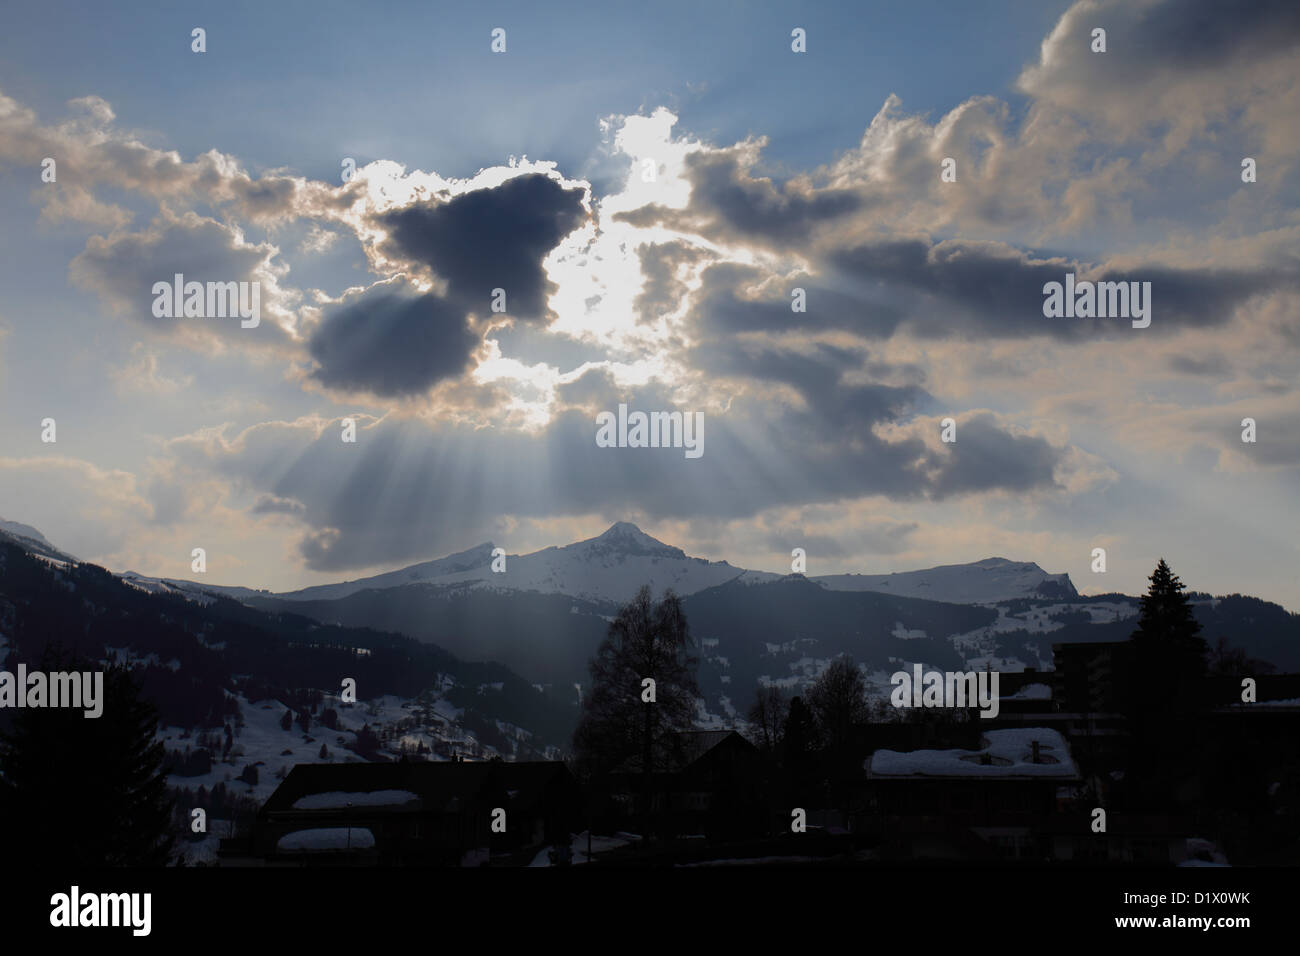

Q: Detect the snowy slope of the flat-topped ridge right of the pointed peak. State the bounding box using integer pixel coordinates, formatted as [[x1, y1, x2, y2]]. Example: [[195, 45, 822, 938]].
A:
[[813, 558, 1078, 604]]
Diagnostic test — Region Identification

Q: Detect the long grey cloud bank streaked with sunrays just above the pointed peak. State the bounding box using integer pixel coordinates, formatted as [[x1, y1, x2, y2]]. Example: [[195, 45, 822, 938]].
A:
[[154, 346, 1091, 571]]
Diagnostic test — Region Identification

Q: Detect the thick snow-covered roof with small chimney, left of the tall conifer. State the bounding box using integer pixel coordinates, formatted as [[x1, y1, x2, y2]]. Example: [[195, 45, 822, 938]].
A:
[[867, 727, 1078, 778]]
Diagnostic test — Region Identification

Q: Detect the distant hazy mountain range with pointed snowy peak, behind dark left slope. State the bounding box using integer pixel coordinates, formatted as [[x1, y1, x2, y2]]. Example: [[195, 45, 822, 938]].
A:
[[0, 522, 1300, 721]]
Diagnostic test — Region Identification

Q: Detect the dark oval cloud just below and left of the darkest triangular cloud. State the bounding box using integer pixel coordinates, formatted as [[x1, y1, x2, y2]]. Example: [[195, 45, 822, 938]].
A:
[[308, 280, 478, 395]]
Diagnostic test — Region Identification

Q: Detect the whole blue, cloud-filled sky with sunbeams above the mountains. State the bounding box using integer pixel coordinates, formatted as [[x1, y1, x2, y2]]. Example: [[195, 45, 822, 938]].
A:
[[0, 0, 1300, 610]]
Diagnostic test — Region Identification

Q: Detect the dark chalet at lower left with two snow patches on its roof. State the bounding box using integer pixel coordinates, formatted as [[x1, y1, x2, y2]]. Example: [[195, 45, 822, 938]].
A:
[[222, 761, 581, 865]]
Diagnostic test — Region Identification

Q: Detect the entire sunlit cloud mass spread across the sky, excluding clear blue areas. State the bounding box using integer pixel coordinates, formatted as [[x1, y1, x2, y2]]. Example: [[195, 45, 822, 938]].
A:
[[0, 0, 1300, 600]]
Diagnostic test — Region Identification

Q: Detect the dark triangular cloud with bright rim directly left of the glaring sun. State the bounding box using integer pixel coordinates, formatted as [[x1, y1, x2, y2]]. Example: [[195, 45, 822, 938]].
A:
[[377, 174, 586, 319]]
